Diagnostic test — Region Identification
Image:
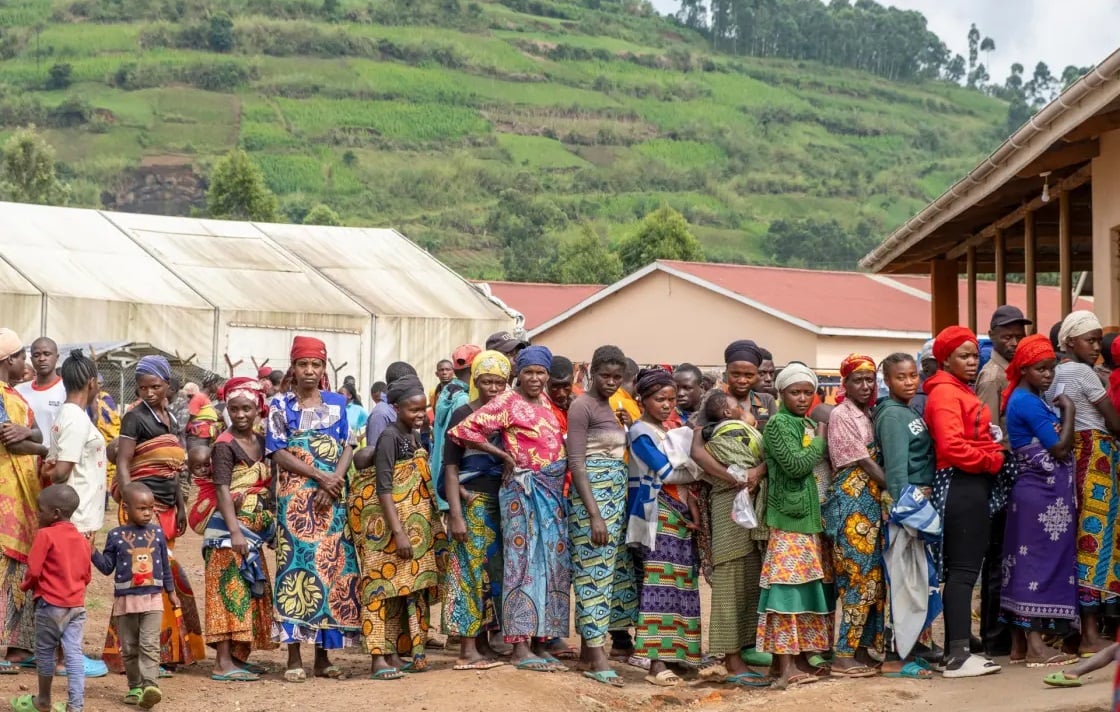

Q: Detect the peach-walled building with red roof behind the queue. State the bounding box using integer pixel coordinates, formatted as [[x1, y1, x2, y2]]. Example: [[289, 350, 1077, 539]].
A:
[[526, 260, 1092, 371]]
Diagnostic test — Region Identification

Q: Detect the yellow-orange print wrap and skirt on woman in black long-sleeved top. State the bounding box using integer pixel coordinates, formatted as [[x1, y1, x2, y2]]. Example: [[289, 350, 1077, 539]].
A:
[[348, 450, 447, 655]]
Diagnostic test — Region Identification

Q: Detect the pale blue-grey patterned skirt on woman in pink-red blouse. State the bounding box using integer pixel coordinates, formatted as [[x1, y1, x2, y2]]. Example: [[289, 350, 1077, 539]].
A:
[[498, 460, 571, 643]]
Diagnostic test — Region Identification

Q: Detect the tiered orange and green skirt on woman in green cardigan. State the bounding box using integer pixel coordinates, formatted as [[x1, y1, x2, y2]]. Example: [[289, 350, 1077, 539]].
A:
[[757, 528, 832, 655]]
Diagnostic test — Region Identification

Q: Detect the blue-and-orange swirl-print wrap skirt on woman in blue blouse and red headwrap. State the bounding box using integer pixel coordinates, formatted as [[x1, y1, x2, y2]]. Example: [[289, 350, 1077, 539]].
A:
[[272, 430, 361, 649]]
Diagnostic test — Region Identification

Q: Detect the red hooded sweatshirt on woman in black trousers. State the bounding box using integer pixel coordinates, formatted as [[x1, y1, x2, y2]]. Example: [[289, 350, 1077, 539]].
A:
[[925, 371, 1004, 475]]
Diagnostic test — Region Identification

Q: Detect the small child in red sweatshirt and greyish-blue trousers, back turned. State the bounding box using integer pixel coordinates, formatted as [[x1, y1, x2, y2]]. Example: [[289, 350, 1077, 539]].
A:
[[11, 485, 91, 712]]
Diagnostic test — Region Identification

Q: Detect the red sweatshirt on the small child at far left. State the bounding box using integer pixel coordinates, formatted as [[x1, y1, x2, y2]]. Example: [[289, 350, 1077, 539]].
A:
[[19, 519, 92, 608]]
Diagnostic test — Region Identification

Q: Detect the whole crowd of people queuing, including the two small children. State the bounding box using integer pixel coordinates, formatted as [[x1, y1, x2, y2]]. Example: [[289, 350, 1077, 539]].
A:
[[0, 306, 1120, 712]]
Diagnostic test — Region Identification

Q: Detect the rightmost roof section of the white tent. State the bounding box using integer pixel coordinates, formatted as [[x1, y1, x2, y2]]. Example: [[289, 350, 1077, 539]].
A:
[[256, 223, 510, 320]]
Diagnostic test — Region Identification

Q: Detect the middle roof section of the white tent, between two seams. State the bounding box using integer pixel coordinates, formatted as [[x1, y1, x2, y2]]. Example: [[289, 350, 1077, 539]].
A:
[[105, 213, 368, 317]]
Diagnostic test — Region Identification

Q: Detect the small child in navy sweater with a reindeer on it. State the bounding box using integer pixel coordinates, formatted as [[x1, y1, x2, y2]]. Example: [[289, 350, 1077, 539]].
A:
[[93, 483, 179, 710]]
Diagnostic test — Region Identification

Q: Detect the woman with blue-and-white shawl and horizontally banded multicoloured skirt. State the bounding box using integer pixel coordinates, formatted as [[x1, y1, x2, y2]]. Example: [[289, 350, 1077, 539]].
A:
[[626, 368, 701, 687]]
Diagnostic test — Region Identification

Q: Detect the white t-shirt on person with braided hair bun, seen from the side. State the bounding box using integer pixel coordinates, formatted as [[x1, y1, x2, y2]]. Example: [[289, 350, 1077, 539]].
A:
[[47, 403, 109, 534]]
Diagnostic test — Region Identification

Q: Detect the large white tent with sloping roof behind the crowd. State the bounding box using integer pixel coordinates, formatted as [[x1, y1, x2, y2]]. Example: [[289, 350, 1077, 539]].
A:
[[0, 203, 514, 385]]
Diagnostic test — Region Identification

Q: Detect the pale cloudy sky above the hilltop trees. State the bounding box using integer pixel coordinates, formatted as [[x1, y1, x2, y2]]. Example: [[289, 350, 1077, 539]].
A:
[[652, 0, 1120, 81]]
